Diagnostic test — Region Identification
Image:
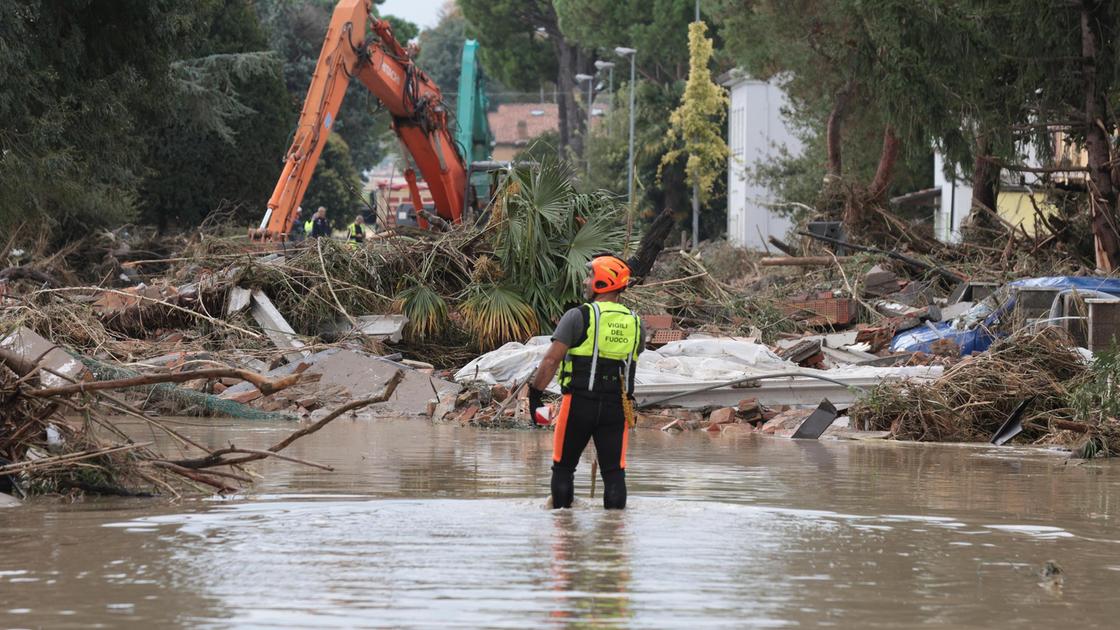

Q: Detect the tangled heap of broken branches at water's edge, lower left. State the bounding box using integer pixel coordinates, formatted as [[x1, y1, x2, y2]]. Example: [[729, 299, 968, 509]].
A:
[[0, 322, 404, 497]]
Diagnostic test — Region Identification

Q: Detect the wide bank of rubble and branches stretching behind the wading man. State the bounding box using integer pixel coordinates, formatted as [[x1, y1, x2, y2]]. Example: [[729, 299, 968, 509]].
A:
[[0, 211, 1120, 504]]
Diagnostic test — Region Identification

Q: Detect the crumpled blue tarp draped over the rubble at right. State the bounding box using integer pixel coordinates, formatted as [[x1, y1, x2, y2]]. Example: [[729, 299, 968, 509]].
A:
[[890, 276, 1120, 355]]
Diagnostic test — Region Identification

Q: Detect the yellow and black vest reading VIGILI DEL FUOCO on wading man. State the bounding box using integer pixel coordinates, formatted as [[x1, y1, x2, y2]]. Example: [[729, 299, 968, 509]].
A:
[[559, 302, 642, 393]]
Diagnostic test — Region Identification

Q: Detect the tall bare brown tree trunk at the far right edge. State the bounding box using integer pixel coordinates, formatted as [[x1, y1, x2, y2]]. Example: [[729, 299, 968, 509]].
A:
[[1081, 0, 1120, 271]]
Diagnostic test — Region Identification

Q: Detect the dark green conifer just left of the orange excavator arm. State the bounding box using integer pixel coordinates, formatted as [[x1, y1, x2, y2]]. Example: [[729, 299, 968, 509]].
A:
[[141, 0, 290, 228]]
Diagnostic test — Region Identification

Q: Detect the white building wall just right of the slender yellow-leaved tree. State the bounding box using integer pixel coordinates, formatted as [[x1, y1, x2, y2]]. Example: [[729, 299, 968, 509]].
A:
[[721, 71, 802, 249]]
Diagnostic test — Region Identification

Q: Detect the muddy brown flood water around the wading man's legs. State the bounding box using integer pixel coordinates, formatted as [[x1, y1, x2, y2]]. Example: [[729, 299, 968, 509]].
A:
[[0, 419, 1120, 628]]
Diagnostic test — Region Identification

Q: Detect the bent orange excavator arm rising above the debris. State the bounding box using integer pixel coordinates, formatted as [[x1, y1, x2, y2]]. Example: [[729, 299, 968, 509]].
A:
[[251, 0, 488, 240]]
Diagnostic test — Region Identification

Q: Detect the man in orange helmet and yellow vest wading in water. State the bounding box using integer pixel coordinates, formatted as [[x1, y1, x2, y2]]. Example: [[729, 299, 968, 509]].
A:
[[529, 256, 643, 510]]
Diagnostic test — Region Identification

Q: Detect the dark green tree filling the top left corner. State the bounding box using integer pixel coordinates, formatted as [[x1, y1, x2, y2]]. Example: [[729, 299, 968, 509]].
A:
[[0, 0, 206, 233]]
